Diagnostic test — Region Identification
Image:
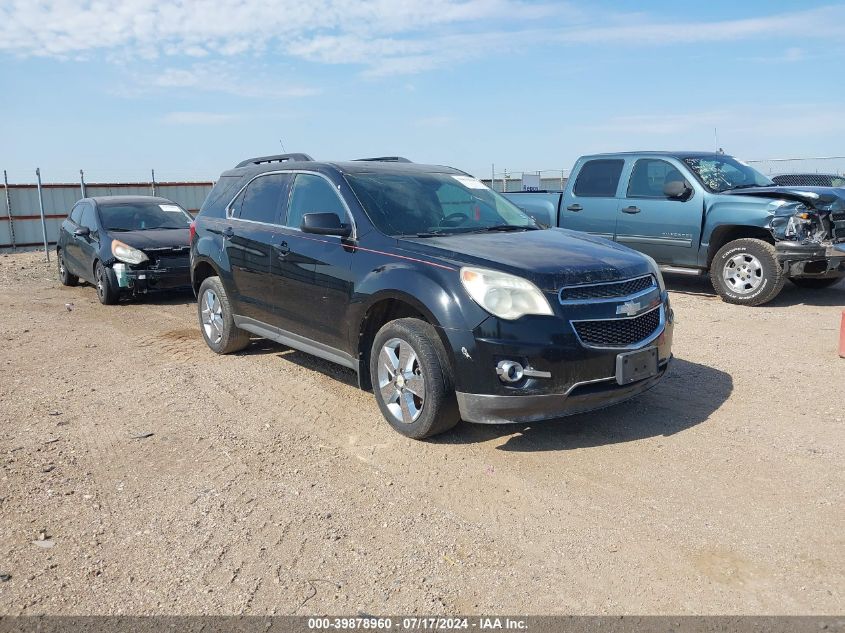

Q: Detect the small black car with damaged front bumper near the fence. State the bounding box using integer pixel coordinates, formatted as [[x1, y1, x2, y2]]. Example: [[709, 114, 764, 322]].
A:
[[56, 196, 192, 305]]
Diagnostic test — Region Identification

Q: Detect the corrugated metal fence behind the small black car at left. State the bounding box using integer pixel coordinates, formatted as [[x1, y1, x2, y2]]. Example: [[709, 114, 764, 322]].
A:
[[0, 175, 214, 249]]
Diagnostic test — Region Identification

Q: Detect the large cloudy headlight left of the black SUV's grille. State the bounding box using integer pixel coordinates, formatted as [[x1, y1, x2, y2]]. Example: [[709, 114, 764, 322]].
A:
[[461, 267, 552, 320]]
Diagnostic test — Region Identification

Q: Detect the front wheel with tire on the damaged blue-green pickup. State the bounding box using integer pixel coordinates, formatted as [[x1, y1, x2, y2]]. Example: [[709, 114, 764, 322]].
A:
[[710, 238, 786, 306]]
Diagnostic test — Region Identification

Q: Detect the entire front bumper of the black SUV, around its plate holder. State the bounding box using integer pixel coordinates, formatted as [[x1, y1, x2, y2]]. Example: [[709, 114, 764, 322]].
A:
[[442, 291, 674, 424]]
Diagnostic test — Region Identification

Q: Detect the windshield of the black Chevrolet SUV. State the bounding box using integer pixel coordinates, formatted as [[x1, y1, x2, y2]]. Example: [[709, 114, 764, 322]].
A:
[[346, 173, 539, 237]]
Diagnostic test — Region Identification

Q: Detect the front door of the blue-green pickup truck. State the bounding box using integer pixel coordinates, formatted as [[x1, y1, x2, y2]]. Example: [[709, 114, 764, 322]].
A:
[[616, 157, 704, 266]]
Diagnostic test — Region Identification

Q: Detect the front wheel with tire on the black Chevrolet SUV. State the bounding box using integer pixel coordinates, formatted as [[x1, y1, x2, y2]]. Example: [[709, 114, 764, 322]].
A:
[[370, 319, 460, 439]]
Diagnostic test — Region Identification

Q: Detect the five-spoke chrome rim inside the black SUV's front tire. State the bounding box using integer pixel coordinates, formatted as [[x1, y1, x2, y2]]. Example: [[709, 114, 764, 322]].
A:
[[378, 338, 425, 424]]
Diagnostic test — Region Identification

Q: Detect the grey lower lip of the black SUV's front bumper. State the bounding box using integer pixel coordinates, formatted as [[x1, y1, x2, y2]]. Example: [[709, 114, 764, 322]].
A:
[[456, 360, 669, 424]]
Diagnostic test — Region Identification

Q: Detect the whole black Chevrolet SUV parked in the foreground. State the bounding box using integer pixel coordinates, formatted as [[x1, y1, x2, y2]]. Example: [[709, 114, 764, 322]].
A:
[[191, 154, 673, 438]]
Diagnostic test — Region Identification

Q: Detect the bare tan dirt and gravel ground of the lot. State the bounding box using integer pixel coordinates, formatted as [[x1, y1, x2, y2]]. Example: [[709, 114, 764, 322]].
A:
[[0, 253, 845, 614]]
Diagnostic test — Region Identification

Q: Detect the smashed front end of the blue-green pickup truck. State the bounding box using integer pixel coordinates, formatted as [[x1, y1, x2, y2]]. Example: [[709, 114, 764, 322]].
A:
[[726, 187, 845, 279]]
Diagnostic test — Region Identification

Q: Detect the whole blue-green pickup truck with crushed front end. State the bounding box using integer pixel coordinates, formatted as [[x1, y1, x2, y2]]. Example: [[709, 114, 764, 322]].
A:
[[505, 152, 845, 305]]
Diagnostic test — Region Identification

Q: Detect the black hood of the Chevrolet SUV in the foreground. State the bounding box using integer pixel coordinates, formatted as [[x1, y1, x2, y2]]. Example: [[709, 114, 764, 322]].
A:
[[399, 228, 652, 291]]
